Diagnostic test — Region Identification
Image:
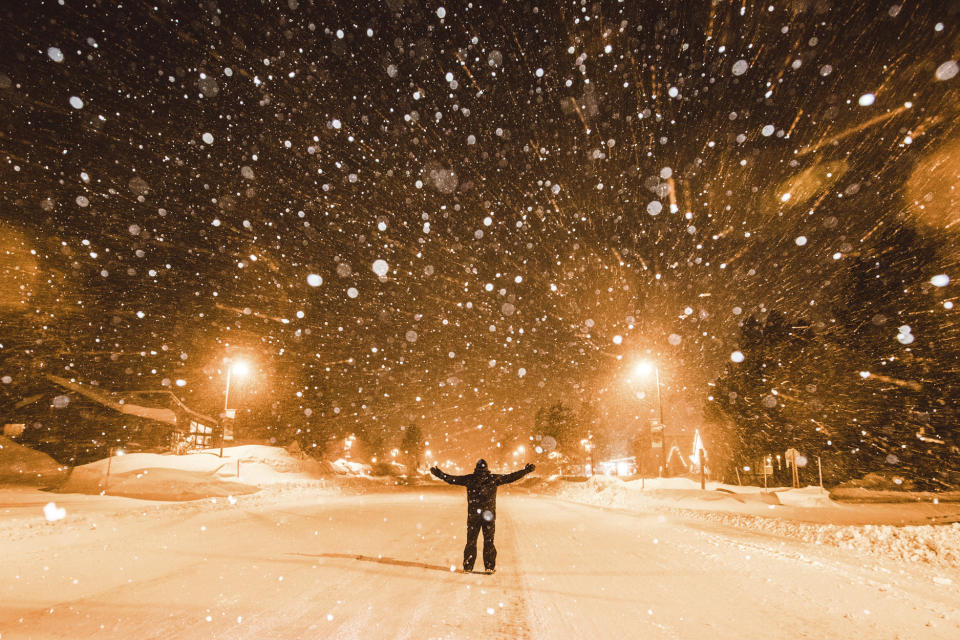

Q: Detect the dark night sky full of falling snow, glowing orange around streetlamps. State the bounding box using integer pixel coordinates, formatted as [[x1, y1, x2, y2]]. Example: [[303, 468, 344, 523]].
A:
[[0, 0, 960, 459]]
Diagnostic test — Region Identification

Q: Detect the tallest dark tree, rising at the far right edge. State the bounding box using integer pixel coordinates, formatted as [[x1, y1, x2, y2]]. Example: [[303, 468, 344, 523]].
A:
[[828, 224, 960, 488]]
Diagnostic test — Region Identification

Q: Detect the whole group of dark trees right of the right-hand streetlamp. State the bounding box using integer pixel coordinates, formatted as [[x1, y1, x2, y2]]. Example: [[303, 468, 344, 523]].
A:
[[707, 226, 960, 489]]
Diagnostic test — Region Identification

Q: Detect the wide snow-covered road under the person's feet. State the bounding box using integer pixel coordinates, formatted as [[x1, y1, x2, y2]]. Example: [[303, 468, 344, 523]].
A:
[[0, 488, 960, 640]]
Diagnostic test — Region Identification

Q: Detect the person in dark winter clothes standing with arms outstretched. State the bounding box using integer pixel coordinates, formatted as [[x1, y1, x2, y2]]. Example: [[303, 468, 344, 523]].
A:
[[430, 459, 535, 573]]
